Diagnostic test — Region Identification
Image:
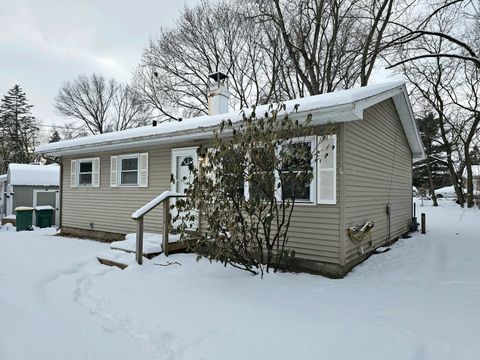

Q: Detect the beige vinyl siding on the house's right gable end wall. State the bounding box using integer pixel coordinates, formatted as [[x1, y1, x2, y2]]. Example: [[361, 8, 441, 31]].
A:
[[344, 99, 412, 263]]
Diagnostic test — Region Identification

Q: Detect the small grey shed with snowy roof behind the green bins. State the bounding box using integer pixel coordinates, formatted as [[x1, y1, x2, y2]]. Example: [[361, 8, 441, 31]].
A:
[[0, 164, 60, 225]]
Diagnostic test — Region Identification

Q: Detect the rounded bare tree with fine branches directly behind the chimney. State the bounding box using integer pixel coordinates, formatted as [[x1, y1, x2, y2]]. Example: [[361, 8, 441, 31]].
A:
[[135, 1, 273, 119]]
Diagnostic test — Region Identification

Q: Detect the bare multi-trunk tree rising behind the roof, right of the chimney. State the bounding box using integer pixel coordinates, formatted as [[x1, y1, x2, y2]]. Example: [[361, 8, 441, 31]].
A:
[[254, 0, 360, 95]]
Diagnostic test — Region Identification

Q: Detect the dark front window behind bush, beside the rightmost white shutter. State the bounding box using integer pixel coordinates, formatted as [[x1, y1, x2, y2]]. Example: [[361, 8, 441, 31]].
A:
[[279, 139, 315, 202]]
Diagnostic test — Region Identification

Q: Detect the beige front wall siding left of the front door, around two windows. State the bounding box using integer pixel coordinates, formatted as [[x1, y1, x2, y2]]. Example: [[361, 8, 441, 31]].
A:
[[62, 147, 170, 234]]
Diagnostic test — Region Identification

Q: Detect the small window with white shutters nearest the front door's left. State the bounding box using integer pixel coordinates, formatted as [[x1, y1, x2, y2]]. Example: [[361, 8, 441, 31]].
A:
[[110, 153, 148, 187]]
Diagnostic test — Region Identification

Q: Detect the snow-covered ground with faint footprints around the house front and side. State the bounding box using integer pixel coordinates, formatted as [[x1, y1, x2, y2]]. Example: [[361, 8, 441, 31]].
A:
[[0, 200, 480, 360]]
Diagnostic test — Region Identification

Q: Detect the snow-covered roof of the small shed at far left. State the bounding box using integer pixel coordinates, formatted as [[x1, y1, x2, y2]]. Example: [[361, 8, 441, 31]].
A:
[[8, 164, 60, 186]]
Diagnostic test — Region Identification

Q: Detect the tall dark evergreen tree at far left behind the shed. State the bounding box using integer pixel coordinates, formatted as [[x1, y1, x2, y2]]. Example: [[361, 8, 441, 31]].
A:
[[0, 85, 38, 173]]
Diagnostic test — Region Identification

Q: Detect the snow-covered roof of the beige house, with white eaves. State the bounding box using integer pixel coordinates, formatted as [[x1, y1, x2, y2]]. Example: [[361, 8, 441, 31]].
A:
[[37, 81, 424, 159]]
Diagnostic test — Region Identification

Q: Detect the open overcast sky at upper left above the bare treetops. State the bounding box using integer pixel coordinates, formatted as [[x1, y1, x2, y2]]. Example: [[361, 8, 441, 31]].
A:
[[0, 0, 198, 136]]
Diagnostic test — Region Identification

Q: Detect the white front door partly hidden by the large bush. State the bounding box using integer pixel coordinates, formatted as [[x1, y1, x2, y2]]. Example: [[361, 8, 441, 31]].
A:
[[171, 148, 197, 228]]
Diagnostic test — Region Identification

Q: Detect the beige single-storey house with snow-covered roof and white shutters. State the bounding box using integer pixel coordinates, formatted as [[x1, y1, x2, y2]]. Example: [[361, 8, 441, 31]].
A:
[[37, 79, 424, 276]]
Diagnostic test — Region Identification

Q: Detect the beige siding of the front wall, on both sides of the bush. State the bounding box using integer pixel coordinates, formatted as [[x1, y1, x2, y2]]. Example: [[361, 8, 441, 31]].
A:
[[62, 132, 340, 264]]
